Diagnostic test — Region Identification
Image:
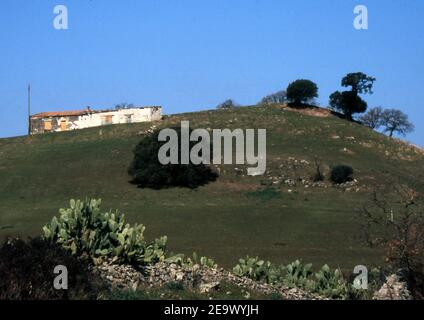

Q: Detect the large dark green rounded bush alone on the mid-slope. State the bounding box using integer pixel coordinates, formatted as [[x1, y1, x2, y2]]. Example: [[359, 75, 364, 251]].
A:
[[128, 128, 218, 189]]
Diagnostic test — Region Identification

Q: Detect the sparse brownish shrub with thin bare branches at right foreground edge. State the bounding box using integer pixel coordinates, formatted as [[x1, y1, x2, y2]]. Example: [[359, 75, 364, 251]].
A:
[[363, 188, 424, 300]]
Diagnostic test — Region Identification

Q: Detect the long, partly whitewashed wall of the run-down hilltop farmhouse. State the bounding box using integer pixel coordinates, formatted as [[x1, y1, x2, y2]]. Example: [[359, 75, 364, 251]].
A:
[[31, 107, 162, 134]]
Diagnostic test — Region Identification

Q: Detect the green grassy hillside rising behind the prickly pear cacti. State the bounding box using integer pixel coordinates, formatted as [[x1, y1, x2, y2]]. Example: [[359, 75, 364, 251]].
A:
[[0, 106, 424, 269]]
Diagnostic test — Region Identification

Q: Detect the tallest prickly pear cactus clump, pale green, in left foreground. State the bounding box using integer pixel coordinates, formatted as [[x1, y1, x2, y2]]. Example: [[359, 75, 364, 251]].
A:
[[43, 200, 167, 265]]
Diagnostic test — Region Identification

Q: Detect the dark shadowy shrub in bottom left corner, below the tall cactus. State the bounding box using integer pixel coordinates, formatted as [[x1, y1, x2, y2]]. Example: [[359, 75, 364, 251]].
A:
[[0, 238, 106, 300]]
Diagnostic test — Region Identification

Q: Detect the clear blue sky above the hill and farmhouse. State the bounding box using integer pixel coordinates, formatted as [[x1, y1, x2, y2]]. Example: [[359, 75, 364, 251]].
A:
[[0, 0, 424, 146]]
